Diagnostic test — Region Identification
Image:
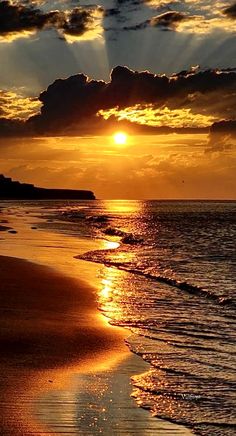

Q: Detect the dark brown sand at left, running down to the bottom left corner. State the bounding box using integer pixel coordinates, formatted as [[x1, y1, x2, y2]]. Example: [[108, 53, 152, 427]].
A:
[[0, 256, 128, 436]]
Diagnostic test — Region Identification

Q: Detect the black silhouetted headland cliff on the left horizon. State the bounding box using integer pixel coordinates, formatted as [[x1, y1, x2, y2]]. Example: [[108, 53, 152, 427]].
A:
[[0, 174, 95, 200]]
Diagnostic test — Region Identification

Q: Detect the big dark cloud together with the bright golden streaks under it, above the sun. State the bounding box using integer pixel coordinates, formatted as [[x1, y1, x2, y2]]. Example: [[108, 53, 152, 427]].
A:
[[0, 66, 236, 135]]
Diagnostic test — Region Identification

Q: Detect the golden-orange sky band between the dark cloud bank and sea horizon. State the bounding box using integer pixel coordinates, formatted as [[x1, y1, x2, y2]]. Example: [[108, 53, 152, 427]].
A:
[[0, 134, 236, 199]]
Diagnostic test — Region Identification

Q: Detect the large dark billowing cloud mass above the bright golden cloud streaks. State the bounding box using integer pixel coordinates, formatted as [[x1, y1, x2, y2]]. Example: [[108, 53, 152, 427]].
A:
[[32, 67, 236, 129]]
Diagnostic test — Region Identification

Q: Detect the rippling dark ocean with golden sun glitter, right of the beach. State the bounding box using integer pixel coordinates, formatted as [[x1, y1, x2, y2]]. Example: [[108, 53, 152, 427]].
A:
[[20, 200, 236, 436]]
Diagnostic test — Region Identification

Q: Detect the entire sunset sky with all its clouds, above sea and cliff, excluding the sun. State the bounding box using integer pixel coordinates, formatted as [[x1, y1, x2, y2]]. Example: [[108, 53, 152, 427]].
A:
[[0, 0, 236, 199]]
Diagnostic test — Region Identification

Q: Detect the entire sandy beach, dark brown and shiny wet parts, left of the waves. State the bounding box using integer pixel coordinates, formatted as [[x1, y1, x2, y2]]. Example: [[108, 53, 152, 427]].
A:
[[0, 208, 192, 436]]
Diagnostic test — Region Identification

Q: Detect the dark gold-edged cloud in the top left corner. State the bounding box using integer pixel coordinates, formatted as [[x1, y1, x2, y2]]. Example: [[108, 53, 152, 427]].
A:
[[0, 1, 101, 41]]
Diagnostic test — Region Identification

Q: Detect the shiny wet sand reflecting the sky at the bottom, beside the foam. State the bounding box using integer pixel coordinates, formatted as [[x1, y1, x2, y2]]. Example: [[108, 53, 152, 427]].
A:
[[36, 354, 188, 436]]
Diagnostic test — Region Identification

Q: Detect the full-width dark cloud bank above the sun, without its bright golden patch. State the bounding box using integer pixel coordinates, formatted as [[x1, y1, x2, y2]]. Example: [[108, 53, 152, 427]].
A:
[[0, 66, 236, 136]]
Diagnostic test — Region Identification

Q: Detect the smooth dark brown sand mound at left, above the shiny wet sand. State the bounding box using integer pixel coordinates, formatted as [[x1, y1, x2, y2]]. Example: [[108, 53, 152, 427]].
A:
[[0, 256, 127, 368]]
